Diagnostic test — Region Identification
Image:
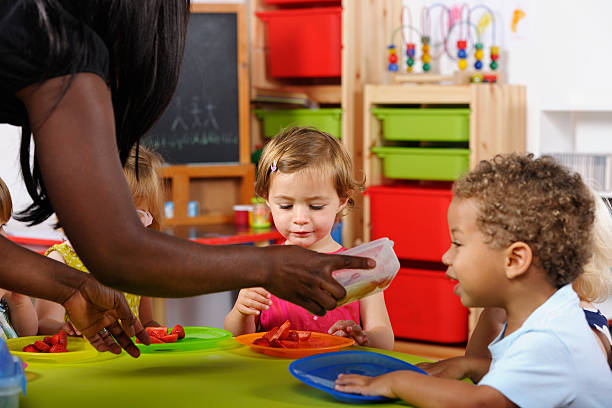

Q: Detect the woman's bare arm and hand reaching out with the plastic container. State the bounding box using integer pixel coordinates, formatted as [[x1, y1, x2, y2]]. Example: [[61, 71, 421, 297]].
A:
[[17, 73, 374, 314]]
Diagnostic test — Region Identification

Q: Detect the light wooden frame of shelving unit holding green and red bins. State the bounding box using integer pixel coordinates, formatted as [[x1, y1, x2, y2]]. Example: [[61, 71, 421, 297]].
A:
[[362, 84, 526, 333]]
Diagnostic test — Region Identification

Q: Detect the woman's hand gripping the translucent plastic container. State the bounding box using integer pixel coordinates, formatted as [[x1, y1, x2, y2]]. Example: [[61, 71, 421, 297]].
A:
[[263, 245, 376, 316]]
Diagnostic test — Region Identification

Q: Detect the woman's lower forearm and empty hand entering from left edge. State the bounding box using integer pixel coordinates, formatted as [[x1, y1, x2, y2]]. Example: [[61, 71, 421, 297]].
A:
[[0, 236, 150, 357]]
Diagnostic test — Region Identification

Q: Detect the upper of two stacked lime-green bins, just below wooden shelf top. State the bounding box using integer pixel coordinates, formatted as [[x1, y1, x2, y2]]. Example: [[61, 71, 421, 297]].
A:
[[372, 108, 470, 142]]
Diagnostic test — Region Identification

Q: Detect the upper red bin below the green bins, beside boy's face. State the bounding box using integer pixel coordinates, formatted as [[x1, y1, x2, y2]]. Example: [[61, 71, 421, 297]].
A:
[[366, 186, 453, 262]]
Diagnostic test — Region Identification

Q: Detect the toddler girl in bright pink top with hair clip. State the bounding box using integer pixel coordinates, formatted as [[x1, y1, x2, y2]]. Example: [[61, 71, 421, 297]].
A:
[[225, 127, 394, 350]]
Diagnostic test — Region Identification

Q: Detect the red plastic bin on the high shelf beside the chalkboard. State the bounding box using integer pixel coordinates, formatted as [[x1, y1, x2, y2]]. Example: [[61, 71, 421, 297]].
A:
[[256, 7, 342, 78]]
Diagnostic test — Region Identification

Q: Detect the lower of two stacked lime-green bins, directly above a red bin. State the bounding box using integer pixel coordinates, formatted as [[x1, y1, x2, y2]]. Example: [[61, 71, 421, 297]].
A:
[[372, 146, 470, 180]]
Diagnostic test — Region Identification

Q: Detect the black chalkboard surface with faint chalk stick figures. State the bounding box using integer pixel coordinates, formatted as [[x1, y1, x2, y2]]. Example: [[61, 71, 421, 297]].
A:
[[144, 13, 240, 164]]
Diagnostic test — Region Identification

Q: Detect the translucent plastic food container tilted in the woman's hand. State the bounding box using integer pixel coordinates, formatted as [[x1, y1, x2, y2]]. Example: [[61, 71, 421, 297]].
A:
[[333, 238, 400, 306]]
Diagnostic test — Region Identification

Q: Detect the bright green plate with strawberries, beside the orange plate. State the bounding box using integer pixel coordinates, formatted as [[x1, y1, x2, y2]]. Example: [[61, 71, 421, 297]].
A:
[[136, 326, 232, 353]]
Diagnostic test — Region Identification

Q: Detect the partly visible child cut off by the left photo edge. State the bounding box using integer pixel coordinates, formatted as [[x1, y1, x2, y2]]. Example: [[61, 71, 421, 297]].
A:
[[0, 179, 38, 339]]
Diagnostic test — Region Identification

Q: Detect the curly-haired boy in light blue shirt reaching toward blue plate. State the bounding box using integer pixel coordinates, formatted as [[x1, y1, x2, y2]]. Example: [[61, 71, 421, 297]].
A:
[[335, 154, 612, 407]]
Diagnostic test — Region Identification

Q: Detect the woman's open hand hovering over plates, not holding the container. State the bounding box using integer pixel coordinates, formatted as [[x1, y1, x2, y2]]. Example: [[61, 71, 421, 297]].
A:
[[62, 277, 151, 357]]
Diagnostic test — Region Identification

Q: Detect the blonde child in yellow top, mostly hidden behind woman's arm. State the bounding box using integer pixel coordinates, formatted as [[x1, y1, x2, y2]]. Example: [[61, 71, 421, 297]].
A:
[[36, 145, 162, 335]]
